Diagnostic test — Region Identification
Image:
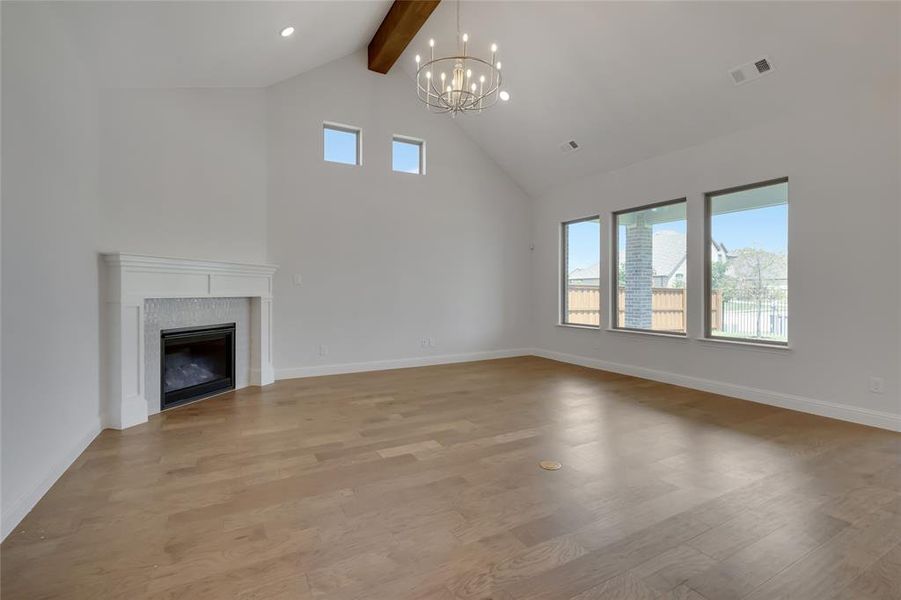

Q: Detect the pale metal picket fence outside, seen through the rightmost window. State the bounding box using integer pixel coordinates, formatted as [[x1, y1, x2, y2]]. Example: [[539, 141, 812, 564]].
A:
[[714, 290, 788, 339]]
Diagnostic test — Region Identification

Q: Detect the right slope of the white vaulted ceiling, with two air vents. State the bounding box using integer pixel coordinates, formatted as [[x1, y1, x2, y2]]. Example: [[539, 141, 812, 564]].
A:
[[399, 1, 901, 195]]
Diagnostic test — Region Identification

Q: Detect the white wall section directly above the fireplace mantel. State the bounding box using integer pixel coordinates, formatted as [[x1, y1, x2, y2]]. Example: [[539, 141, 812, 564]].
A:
[[100, 88, 267, 262]]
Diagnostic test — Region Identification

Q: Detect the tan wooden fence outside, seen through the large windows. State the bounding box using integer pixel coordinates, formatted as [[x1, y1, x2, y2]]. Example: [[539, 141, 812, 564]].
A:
[[567, 286, 723, 332]]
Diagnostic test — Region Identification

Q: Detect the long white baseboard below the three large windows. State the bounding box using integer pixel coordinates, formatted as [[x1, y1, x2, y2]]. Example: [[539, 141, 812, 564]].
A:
[[532, 348, 901, 431]]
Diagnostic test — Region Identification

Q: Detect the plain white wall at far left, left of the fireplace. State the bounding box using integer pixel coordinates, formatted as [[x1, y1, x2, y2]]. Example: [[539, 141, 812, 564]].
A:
[[2, 2, 100, 536]]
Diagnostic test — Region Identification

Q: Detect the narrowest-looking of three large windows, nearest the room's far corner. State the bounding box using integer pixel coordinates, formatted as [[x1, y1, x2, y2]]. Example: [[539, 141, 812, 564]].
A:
[[561, 217, 601, 327]]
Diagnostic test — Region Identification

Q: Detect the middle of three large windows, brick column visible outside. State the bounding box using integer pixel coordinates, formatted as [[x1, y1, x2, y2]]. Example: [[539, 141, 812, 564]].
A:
[[612, 199, 688, 334]]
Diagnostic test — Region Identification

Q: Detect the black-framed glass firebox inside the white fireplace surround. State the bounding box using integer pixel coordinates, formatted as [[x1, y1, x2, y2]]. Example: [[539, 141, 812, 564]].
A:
[[160, 323, 235, 409]]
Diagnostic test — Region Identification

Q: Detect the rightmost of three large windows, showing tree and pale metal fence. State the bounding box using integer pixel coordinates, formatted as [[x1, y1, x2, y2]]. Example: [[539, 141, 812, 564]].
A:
[[705, 179, 788, 345]]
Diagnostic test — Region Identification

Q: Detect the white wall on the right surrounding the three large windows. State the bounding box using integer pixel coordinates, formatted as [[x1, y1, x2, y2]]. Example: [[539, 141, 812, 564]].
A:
[[532, 90, 901, 428]]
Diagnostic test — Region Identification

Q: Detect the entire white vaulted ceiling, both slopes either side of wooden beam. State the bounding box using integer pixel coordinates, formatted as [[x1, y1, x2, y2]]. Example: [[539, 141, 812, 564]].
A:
[[51, 0, 901, 196]]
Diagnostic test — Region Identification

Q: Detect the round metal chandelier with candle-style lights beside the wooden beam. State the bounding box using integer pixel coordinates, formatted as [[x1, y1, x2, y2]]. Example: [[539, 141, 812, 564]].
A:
[[415, 0, 510, 116]]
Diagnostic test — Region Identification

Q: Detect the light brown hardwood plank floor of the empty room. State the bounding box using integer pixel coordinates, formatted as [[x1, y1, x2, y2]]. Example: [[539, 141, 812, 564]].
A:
[[0, 358, 901, 600]]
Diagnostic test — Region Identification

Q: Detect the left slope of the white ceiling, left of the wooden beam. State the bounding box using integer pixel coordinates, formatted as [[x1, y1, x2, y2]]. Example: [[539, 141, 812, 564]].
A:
[[49, 0, 391, 87]]
